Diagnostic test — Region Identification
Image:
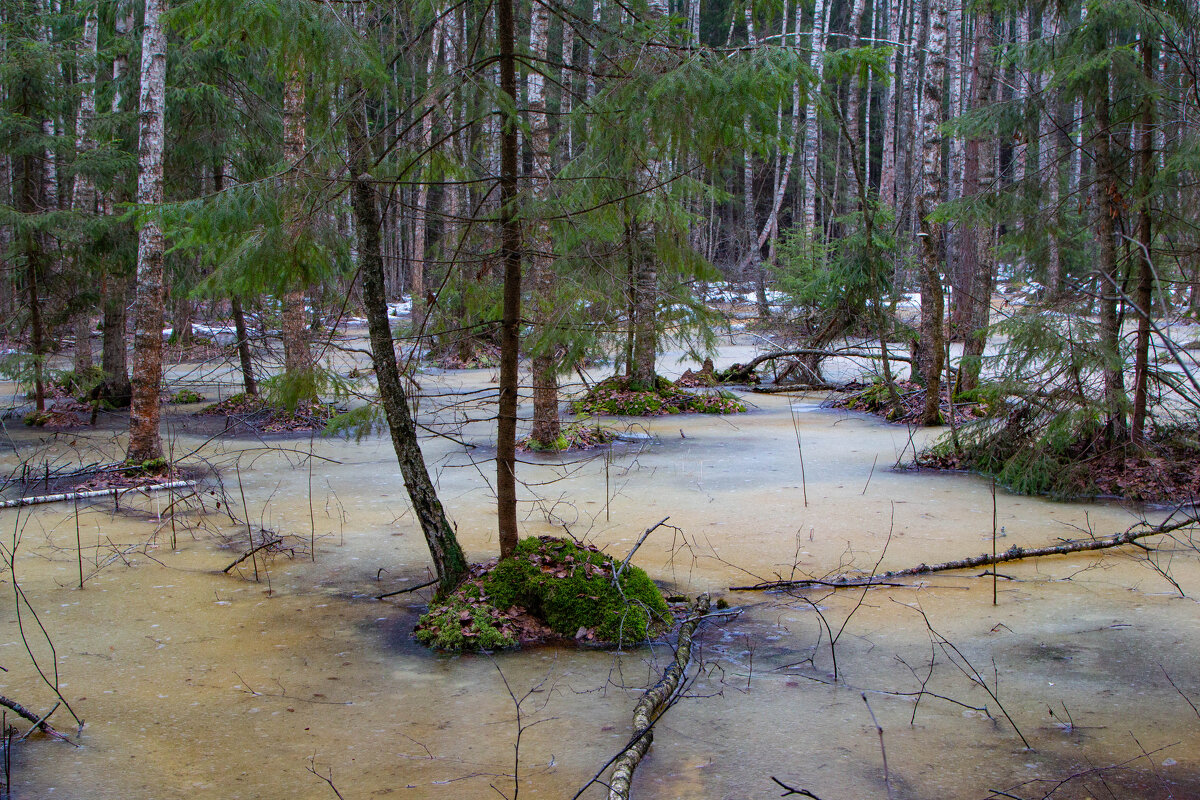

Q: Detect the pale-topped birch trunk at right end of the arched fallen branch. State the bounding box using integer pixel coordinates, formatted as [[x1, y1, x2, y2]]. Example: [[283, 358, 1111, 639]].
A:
[[917, 0, 947, 425]]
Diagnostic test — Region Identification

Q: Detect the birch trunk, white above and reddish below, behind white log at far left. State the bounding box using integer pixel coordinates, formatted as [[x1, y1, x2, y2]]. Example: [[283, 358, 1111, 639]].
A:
[[125, 0, 167, 464]]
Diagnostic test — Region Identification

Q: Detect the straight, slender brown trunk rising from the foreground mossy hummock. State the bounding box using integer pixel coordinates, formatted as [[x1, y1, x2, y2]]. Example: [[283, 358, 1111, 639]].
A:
[[496, 0, 521, 558]]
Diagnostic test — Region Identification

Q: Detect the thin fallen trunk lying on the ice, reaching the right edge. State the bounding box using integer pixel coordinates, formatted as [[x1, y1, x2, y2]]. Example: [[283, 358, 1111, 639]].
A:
[[730, 517, 1200, 591]]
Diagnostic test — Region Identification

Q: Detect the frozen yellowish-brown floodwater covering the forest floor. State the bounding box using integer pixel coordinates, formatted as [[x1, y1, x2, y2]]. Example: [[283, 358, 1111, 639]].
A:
[[0, 340, 1200, 800]]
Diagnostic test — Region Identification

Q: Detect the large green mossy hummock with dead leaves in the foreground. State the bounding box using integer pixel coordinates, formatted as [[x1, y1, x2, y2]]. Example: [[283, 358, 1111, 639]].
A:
[[416, 536, 668, 651]]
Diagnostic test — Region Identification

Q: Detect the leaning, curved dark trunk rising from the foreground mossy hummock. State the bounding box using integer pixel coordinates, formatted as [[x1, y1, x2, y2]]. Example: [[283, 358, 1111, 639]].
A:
[[344, 86, 468, 597]]
